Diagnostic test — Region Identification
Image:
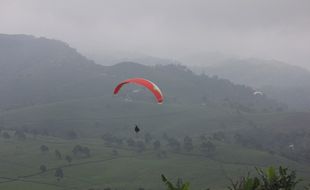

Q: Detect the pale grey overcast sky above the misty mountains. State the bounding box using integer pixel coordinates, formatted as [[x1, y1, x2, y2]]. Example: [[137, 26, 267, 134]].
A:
[[0, 0, 310, 68]]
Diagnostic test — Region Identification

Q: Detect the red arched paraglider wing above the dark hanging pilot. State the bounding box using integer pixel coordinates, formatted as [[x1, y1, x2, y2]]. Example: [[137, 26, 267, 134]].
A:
[[114, 78, 164, 103]]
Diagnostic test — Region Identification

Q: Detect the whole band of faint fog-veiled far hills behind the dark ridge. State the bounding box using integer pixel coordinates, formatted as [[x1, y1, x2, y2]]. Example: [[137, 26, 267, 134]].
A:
[[89, 49, 310, 111]]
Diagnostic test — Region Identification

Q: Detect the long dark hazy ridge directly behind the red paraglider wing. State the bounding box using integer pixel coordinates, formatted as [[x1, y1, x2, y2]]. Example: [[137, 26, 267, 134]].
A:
[[0, 34, 283, 111]]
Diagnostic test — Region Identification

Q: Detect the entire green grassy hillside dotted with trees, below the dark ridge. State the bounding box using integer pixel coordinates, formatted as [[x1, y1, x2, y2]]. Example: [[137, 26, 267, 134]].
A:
[[0, 97, 310, 190]]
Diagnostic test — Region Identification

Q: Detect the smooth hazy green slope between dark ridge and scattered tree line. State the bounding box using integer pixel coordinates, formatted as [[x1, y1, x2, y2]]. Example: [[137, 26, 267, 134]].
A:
[[0, 97, 310, 137]]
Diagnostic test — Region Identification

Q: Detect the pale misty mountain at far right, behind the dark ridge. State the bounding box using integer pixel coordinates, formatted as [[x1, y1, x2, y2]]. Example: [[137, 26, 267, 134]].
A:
[[191, 59, 310, 110]]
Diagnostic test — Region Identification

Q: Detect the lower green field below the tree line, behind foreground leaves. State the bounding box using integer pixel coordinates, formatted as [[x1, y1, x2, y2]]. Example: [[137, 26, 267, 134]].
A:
[[0, 137, 310, 190]]
